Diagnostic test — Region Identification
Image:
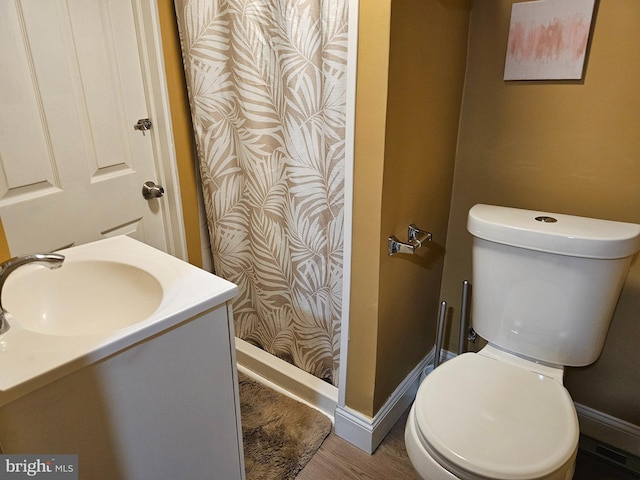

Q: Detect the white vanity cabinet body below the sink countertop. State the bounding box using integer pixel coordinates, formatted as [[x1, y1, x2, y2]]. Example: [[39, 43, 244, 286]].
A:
[[0, 304, 244, 480]]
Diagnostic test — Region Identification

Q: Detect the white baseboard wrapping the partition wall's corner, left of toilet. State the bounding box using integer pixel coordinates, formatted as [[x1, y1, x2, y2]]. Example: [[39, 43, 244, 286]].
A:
[[334, 350, 434, 454]]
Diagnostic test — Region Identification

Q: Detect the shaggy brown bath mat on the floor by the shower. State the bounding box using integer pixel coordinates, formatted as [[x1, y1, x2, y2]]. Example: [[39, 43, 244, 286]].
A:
[[238, 373, 331, 480]]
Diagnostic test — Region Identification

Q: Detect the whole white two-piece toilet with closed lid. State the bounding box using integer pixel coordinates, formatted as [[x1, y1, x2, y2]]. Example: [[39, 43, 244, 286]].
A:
[[405, 205, 640, 480]]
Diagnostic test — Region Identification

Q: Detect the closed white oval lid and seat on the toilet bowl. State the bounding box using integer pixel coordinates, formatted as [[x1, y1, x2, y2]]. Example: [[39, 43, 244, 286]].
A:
[[415, 353, 579, 480]]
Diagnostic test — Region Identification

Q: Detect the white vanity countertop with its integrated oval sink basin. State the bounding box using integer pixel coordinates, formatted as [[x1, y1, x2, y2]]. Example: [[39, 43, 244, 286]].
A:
[[0, 236, 237, 404]]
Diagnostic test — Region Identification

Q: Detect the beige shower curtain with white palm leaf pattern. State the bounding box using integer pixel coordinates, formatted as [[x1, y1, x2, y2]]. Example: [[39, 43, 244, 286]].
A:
[[175, 0, 347, 384]]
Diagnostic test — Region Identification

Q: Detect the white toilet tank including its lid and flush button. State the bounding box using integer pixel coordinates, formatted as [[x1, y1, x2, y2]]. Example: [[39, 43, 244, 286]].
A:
[[467, 205, 640, 366]]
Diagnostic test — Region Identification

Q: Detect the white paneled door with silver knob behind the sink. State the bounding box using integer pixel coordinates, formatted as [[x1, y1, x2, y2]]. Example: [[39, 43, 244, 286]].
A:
[[0, 0, 180, 255]]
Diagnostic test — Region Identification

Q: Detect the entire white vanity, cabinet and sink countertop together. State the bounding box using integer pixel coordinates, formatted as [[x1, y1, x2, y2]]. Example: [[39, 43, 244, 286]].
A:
[[0, 236, 244, 480]]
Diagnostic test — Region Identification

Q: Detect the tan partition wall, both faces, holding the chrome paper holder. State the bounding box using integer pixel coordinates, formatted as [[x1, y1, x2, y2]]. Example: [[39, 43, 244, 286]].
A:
[[346, 0, 469, 416]]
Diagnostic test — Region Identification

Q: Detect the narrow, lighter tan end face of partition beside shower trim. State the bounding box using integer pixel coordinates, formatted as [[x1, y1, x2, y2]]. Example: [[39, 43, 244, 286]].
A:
[[346, 0, 391, 416]]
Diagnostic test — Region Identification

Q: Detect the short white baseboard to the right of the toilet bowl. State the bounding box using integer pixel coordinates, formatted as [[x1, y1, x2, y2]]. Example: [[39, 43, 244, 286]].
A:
[[575, 403, 640, 457]]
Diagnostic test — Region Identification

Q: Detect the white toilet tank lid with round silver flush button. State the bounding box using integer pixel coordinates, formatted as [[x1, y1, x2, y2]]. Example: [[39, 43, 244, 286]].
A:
[[467, 204, 640, 259]]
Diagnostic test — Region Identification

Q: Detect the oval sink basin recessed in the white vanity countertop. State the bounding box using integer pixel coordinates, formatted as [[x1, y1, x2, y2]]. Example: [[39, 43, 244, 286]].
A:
[[2, 259, 163, 335]]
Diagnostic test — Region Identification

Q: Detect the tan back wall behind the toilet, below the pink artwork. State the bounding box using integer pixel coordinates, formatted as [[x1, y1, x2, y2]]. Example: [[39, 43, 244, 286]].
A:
[[441, 0, 640, 425]]
